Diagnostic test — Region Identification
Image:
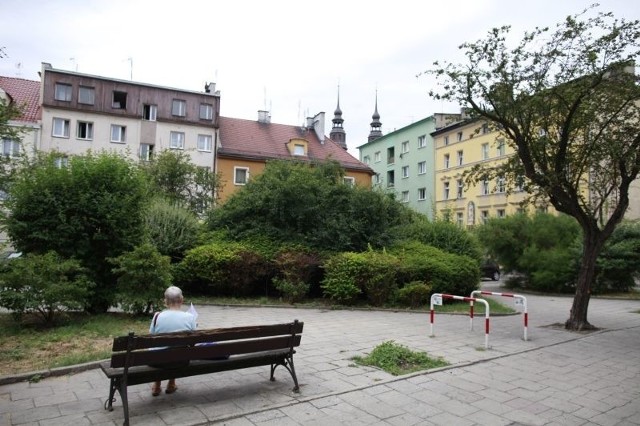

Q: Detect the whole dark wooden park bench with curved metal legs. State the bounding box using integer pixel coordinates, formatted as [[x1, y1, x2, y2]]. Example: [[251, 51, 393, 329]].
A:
[[100, 320, 304, 426]]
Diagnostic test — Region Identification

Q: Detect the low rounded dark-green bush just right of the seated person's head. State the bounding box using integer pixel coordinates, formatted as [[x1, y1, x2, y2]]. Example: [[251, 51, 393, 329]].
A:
[[175, 241, 269, 297]]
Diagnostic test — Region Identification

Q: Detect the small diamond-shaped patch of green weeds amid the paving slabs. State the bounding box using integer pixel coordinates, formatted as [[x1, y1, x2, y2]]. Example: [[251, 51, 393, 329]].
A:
[[351, 340, 449, 376]]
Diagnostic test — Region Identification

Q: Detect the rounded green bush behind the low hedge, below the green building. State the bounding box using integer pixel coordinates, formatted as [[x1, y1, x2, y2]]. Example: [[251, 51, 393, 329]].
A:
[[394, 217, 482, 261]]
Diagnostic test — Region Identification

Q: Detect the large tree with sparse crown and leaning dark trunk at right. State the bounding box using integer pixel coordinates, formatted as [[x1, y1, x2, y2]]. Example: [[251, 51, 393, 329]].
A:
[[427, 6, 640, 330]]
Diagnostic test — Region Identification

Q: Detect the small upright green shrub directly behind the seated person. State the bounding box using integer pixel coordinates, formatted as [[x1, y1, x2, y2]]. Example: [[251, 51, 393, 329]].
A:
[[110, 243, 172, 314]]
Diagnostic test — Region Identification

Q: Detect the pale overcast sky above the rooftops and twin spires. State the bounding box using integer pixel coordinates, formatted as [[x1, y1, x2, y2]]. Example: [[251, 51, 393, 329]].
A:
[[0, 0, 640, 157]]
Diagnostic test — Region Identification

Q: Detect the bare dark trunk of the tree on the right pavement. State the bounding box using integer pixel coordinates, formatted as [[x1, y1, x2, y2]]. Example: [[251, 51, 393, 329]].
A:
[[564, 230, 602, 331]]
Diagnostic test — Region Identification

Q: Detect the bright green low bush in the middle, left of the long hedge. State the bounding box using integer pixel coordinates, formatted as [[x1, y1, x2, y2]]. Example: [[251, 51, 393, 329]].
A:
[[322, 250, 399, 306]]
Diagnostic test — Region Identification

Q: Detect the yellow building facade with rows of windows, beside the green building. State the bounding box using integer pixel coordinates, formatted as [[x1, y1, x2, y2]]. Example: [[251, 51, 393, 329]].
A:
[[431, 119, 547, 226]]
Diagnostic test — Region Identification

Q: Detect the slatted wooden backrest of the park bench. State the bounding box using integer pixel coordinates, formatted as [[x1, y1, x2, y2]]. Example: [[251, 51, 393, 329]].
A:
[[111, 320, 304, 368]]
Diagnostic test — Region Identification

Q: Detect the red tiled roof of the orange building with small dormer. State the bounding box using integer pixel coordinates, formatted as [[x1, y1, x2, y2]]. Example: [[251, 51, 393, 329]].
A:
[[218, 117, 373, 174]]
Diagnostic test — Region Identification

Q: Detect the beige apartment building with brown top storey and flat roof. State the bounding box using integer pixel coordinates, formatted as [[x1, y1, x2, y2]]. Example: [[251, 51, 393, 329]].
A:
[[39, 63, 220, 168]]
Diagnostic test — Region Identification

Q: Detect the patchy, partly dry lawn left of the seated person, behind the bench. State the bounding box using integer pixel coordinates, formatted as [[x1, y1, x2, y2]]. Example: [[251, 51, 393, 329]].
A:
[[0, 313, 150, 375]]
